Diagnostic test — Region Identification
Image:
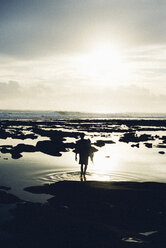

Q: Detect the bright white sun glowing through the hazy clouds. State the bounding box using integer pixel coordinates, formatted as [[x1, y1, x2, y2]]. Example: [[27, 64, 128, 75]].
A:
[[77, 44, 126, 84]]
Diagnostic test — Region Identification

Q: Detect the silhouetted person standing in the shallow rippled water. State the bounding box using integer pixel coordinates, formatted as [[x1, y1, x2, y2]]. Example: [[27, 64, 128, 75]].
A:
[[75, 133, 91, 176]]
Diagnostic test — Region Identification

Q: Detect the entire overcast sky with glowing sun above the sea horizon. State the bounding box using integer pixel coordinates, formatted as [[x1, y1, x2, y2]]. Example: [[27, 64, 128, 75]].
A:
[[0, 0, 166, 112]]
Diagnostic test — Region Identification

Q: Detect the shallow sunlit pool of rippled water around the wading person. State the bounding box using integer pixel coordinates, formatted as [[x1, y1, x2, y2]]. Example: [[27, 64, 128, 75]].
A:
[[0, 132, 166, 200]]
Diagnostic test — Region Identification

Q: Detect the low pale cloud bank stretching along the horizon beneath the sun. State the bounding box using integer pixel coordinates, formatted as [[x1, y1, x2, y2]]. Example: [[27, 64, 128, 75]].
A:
[[0, 82, 166, 112]]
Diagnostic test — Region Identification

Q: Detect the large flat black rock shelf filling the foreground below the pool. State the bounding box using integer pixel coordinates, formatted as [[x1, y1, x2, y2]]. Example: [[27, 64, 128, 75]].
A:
[[0, 181, 166, 248]]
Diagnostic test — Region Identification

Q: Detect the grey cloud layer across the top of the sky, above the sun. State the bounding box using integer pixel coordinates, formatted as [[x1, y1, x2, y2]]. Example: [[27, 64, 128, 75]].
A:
[[0, 0, 166, 58]]
